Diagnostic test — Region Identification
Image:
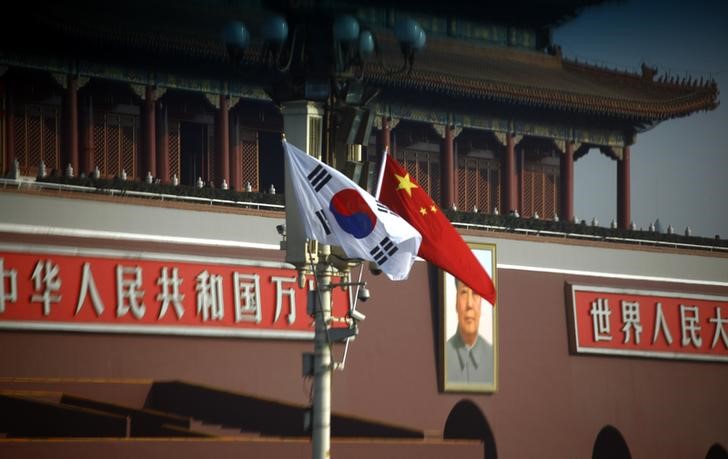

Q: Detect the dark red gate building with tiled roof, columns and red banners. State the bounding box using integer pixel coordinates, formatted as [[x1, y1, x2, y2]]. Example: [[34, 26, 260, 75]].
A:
[[0, 2, 728, 459]]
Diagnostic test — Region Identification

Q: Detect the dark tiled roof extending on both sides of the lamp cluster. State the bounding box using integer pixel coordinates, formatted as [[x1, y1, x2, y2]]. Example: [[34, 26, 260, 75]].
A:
[[5, 4, 718, 123]]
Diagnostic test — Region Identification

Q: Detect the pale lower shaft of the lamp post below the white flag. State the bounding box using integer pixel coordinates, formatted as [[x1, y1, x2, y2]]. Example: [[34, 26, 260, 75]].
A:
[[312, 244, 332, 459]]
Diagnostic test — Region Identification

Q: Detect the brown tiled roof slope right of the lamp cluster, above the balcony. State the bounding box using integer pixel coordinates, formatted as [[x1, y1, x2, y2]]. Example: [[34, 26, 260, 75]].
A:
[[365, 33, 718, 121]]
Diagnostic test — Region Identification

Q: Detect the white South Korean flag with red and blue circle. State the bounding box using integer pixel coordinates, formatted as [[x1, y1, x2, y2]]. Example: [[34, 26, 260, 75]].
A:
[[283, 141, 422, 280]]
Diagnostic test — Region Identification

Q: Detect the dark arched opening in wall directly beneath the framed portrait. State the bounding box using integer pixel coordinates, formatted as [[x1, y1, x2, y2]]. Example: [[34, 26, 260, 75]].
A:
[[443, 400, 498, 459]]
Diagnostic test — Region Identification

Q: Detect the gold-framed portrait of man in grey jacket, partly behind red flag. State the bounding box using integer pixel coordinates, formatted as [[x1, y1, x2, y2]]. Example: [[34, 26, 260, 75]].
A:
[[440, 243, 498, 393]]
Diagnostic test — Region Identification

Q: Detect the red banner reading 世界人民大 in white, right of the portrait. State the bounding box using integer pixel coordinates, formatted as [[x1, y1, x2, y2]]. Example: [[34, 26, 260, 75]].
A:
[[571, 285, 728, 361]]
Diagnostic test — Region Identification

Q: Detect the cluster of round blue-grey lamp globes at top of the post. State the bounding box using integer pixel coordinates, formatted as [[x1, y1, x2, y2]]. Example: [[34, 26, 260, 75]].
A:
[[223, 8, 427, 101]]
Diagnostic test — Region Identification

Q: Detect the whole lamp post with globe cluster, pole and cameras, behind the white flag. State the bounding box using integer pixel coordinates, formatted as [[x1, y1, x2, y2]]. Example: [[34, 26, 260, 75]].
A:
[[223, 8, 426, 459]]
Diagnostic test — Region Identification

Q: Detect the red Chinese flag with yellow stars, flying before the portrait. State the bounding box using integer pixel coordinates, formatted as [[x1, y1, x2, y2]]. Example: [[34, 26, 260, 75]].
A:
[[379, 155, 495, 305]]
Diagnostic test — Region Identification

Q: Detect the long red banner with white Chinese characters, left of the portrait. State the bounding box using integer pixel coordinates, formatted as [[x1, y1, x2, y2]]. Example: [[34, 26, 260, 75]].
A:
[[0, 250, 348, 339]]
